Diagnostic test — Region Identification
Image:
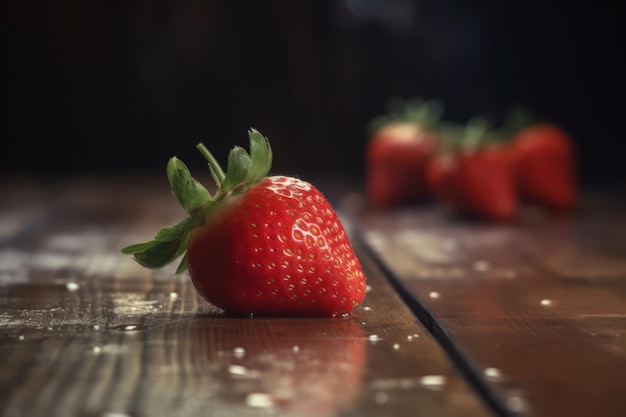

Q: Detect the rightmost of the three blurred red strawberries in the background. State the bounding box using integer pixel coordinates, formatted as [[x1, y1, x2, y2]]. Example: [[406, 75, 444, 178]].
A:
[[511, 123, 576, 210]]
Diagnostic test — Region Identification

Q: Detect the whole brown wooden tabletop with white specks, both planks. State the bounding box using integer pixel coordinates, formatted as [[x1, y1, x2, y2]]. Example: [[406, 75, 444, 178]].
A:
[[0, 177, 626, 417]]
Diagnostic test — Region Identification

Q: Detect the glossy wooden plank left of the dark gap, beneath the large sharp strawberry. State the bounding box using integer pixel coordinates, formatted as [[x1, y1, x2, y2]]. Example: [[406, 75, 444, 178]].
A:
[[0, 179, 493, 417]]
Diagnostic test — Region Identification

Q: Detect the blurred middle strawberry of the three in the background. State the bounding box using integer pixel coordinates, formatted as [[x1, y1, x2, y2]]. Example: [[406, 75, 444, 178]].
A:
[[427, 121, 517, 221]]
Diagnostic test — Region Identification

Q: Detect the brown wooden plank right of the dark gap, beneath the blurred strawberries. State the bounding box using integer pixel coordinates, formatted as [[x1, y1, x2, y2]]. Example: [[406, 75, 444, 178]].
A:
[[355, 195, 626, 417]]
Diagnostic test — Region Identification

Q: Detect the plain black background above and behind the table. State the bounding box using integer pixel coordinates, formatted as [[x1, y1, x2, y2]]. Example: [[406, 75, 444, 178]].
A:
[[6, 0, 626, 185]]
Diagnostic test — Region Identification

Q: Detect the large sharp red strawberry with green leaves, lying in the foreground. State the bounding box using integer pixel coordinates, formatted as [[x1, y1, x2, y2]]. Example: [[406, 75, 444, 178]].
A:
[[122, 129, 365, 316]]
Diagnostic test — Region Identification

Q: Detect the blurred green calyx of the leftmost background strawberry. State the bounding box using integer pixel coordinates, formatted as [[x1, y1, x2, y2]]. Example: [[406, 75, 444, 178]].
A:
[[367, 98, 443, 135]]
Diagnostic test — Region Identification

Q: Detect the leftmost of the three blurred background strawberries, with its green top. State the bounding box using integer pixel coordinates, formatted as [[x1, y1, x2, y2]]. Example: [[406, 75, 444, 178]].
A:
[[366, 97, 442, 209]]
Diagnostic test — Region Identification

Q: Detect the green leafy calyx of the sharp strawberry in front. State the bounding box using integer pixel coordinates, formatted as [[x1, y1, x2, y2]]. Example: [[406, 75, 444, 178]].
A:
[[121, 129, 272, 274]]
